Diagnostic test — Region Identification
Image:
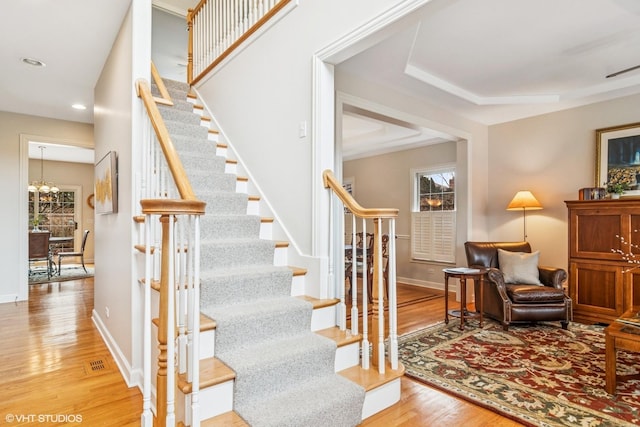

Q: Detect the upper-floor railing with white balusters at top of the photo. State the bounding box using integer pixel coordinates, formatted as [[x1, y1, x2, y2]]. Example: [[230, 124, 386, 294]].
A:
[[187, 0, 291, 85]]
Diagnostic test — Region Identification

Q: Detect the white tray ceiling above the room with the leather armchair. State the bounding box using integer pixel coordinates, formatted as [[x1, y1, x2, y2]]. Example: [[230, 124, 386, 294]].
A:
[[339, 0, 640, 125]]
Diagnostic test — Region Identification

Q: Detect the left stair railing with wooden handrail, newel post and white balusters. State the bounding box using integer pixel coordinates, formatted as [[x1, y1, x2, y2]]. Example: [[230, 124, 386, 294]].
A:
[[136, 77, 205, 427]]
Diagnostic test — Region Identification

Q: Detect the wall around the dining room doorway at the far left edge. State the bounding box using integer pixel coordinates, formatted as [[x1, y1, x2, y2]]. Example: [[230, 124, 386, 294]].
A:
[[0, 112, 93, 303]]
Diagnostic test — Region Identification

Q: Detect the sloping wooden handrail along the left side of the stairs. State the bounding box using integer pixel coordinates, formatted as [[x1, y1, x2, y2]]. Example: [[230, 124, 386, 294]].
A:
[[136, 79, 197, 200]]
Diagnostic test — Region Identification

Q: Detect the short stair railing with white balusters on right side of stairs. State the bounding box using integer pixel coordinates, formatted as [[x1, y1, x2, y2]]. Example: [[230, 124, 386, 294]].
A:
[[322, 170, 398, 373]]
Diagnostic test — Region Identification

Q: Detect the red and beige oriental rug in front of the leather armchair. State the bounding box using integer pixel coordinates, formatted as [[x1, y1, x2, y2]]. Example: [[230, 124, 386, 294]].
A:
[[399, 319, 640, 427]]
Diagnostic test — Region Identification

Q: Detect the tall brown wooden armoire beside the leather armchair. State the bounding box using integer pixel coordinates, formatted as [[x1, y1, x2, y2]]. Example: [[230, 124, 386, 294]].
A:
[[565, 198, 640, 324]]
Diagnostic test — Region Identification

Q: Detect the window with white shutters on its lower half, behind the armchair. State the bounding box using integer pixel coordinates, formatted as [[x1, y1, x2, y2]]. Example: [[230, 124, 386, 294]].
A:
[[411, 165, 456, 263]]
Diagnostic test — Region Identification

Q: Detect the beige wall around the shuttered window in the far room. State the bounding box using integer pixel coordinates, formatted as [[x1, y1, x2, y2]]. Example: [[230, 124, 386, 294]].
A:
[[343, 142, 464, 287]]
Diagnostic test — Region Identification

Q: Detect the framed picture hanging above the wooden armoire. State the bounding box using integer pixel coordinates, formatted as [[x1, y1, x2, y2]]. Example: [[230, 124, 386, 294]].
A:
[[595, 122, 640, 195]]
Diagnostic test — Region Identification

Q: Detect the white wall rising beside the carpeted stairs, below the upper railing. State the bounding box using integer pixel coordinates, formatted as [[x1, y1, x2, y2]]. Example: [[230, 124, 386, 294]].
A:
[[197, 0, 430, 254]]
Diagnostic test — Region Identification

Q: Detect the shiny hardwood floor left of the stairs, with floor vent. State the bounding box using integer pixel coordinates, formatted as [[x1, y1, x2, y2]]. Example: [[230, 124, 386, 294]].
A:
[[0, 278, 142, 426]]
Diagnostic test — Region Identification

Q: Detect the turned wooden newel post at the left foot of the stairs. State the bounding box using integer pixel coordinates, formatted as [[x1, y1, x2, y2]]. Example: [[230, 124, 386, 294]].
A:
[[156, 215, 173, 427]]
